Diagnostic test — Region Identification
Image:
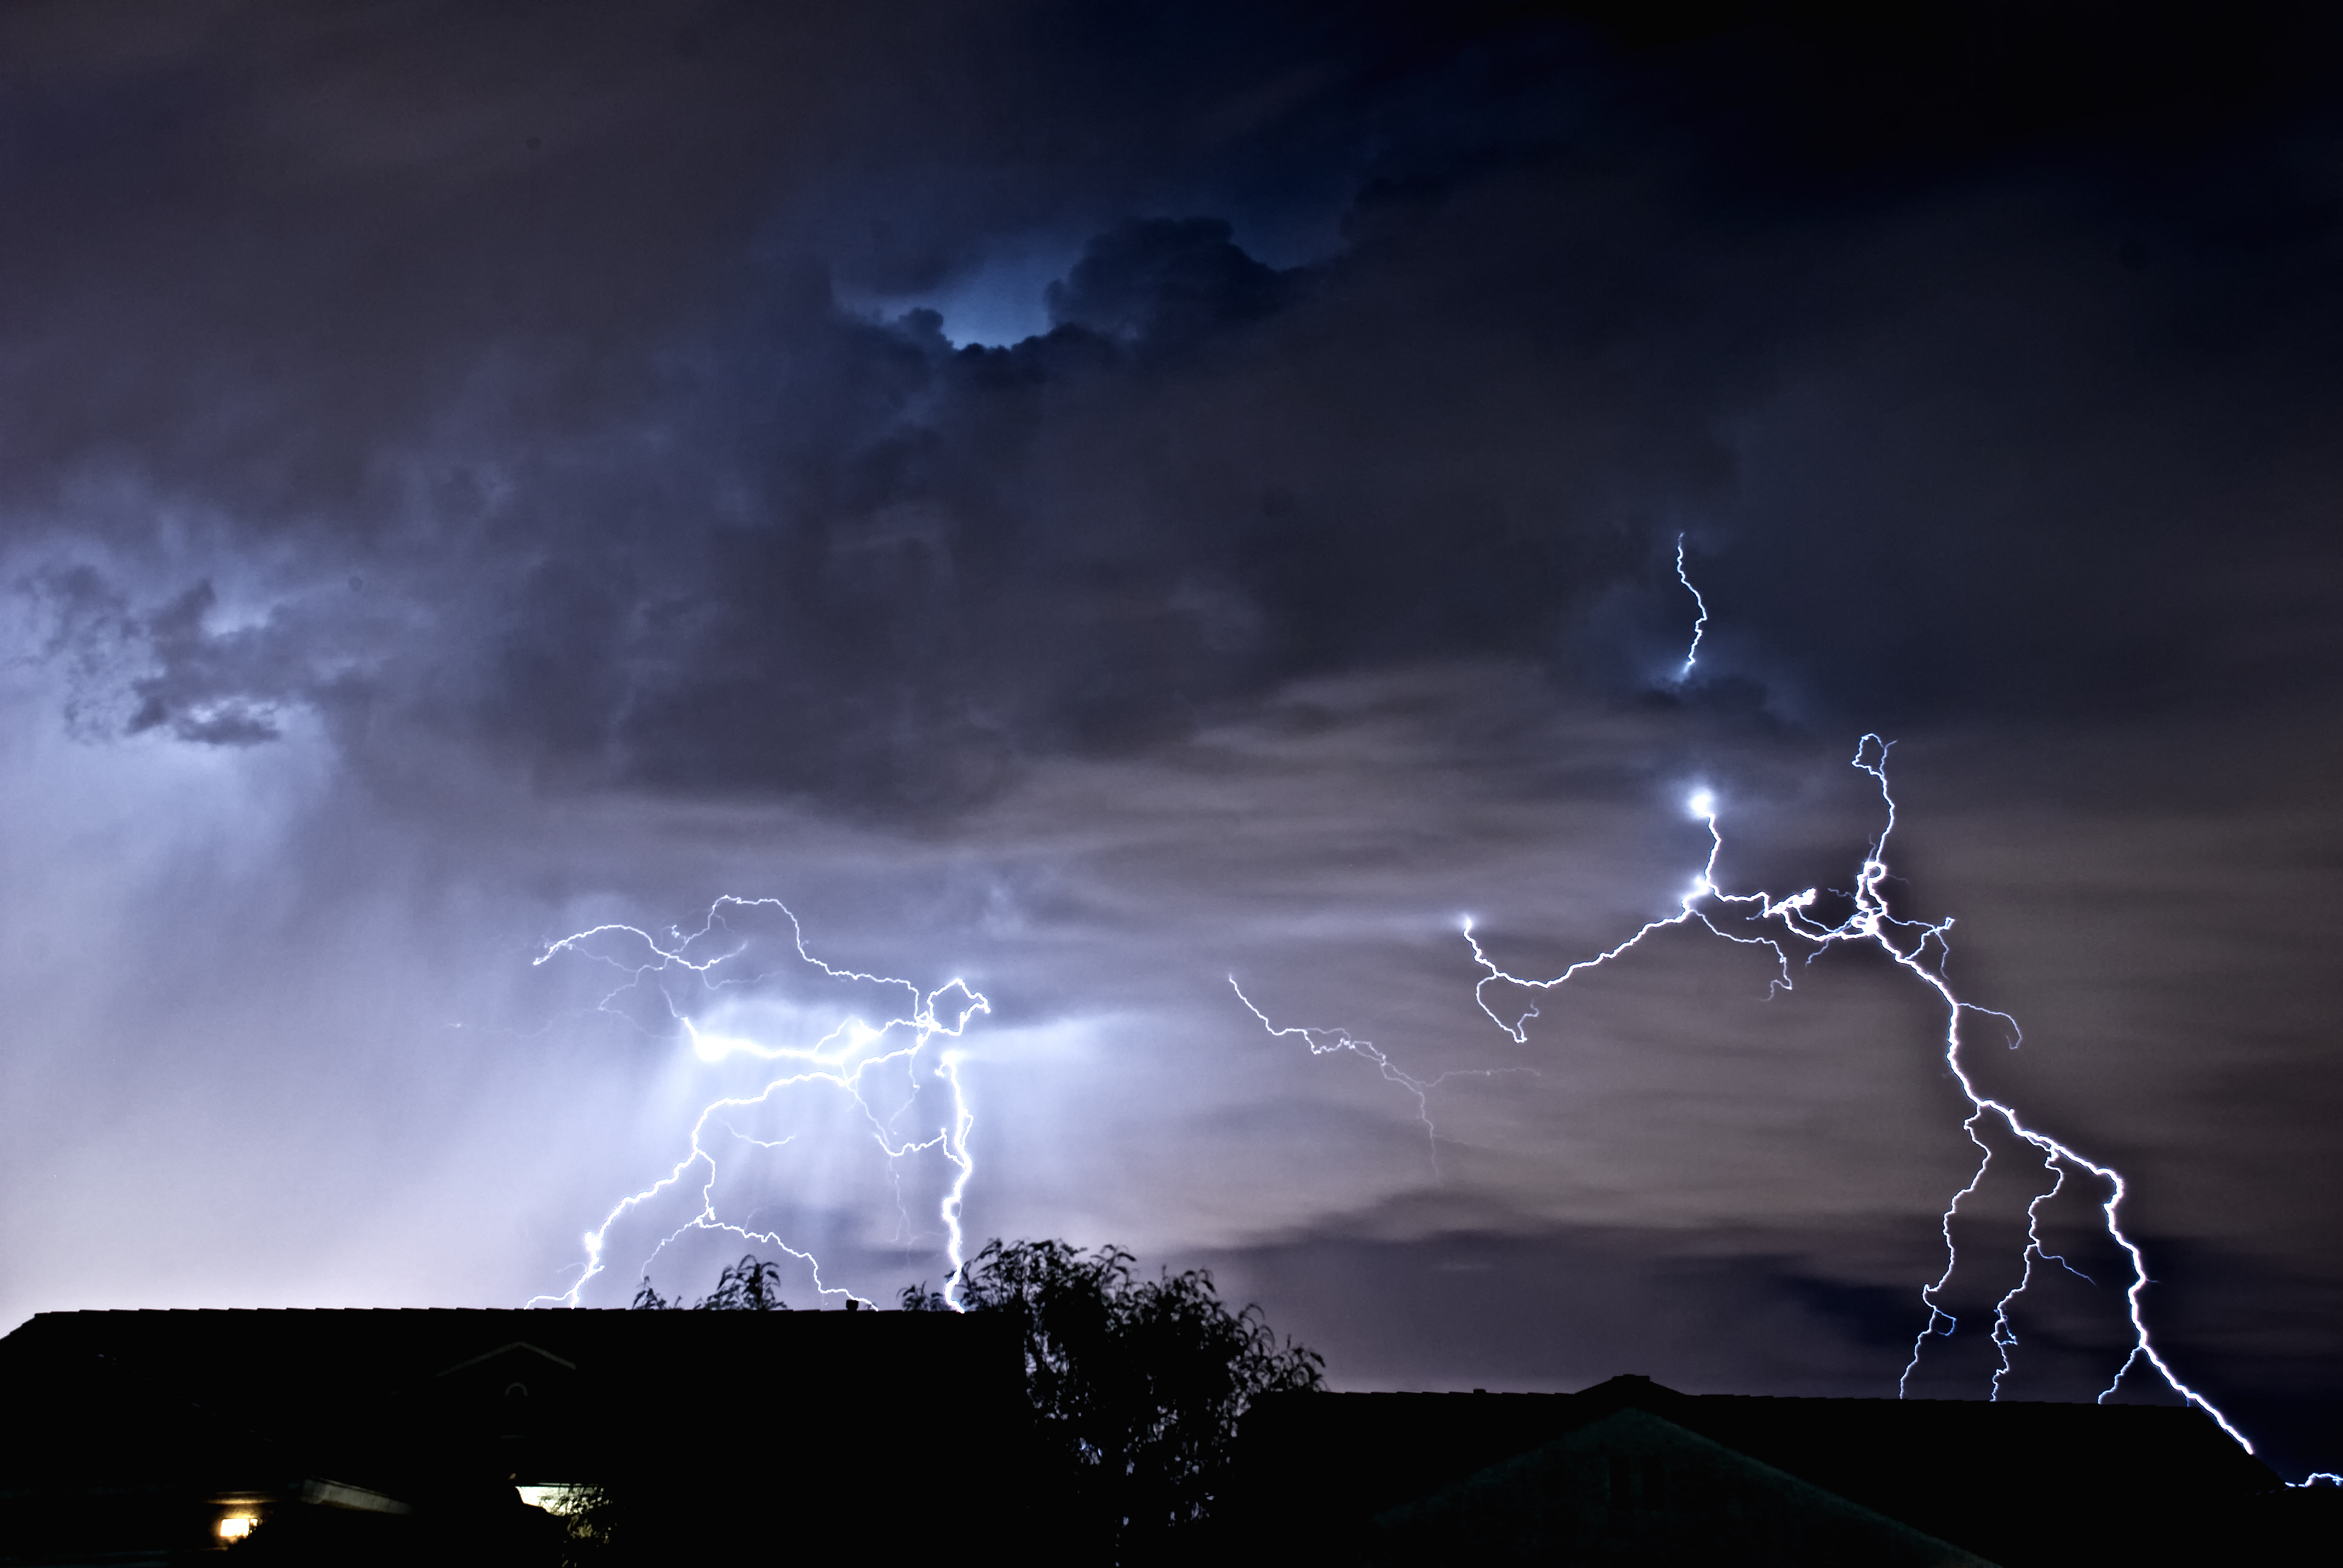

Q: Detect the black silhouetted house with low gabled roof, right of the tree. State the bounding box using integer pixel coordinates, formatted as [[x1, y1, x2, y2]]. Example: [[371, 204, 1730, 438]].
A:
[[1225, 1378, 2334, 1568]]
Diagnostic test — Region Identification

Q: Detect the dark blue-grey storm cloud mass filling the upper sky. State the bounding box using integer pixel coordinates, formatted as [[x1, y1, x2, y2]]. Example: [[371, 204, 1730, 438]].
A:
[[0, 7, 2343, 809]]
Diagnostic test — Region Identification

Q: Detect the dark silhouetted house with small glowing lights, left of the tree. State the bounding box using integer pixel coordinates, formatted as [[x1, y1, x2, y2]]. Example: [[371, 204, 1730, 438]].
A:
[[0, 1310, 1029, 1563]]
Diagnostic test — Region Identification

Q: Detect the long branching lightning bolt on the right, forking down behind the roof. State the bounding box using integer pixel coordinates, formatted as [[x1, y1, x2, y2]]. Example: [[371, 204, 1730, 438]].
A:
[[1464, 550, 2254, 1453]]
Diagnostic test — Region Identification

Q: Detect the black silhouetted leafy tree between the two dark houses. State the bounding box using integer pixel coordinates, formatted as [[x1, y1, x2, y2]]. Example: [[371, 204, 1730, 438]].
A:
[[902, 1240, 1326, 1554]]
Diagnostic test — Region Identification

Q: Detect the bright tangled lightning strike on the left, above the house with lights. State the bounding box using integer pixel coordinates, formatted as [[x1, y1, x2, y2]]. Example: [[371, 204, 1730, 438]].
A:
[[529, 895, 991, 1310]]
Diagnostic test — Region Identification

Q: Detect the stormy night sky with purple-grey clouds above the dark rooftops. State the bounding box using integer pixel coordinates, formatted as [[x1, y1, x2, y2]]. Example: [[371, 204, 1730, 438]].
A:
[[0, 0, 2343, 1477]]
